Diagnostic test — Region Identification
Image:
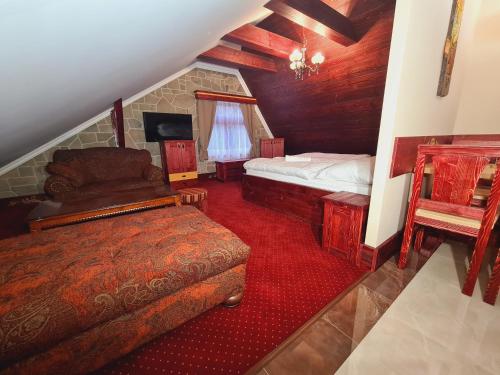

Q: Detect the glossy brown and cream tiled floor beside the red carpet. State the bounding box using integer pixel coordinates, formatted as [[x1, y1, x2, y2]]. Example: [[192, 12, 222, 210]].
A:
[[251, 243, 500, 375]]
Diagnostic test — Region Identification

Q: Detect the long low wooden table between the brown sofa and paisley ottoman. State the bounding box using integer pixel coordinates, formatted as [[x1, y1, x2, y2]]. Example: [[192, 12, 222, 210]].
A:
[[27, 186, 181, 232]]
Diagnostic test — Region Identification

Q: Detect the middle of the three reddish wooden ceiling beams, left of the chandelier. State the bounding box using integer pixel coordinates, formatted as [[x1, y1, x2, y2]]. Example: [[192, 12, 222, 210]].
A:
[[222, 24, 301, 59]]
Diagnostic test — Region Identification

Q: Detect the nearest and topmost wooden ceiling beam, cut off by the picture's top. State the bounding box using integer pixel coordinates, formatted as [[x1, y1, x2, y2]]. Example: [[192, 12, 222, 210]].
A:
[[265, 0, 358, 46]]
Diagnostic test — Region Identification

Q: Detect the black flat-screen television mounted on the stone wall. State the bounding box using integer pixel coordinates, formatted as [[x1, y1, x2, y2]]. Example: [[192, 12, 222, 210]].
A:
[[143, 112, 193, 142]]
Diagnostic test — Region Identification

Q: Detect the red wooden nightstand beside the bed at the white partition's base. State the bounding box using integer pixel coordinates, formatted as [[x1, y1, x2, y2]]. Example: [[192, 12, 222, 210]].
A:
[[321, 192, 370, 265]]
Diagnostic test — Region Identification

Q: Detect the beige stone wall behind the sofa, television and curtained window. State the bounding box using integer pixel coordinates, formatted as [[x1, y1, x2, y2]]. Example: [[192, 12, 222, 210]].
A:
[[0, 68, 268, 198]]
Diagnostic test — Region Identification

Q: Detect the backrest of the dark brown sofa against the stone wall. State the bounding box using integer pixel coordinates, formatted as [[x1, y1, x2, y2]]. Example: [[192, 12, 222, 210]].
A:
[[53, 147, 152, 184]]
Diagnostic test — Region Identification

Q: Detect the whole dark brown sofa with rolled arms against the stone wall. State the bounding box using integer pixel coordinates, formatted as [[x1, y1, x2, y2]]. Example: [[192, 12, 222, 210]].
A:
[[44, 147, 163, 201]]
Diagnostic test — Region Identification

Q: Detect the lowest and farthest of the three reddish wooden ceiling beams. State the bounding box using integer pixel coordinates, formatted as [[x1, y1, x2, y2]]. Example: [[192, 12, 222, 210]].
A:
[[198, 46, 278, 73]]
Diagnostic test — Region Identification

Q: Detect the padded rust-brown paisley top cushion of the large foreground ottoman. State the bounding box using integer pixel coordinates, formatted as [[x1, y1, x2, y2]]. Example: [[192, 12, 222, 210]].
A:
[[0, 206, 249, 363]]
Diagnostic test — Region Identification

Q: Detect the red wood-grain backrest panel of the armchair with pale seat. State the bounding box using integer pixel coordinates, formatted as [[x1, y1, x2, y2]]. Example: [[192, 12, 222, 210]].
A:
[[431, 154, 490, 206]]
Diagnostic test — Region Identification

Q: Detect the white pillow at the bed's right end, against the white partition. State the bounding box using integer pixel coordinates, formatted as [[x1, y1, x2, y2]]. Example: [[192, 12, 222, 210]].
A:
[[316, 156, 375, 185]]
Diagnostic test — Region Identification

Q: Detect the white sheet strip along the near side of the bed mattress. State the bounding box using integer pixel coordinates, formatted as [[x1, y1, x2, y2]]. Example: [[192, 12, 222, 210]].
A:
[[246, 168, 372, 195]]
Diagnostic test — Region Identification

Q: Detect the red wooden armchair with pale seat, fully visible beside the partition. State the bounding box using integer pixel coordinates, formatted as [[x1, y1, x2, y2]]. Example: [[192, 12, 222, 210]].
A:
[[399, 145, 500, 296]]
